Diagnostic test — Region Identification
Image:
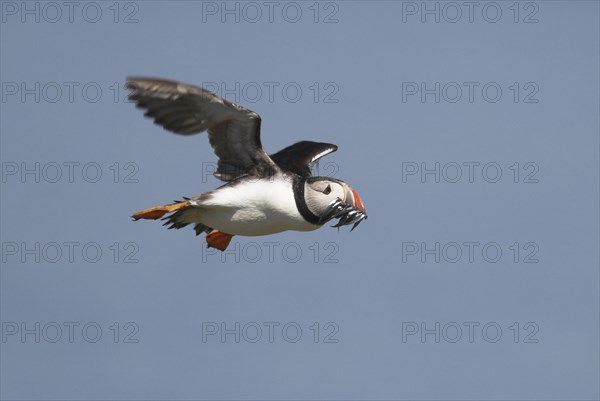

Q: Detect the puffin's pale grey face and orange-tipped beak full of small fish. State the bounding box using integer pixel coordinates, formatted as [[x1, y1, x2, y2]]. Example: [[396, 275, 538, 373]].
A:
[[304, 177, 367, 230]]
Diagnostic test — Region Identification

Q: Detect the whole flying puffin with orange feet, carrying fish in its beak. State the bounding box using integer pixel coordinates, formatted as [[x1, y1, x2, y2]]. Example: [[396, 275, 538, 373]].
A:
[[126, 78, 367, 251]]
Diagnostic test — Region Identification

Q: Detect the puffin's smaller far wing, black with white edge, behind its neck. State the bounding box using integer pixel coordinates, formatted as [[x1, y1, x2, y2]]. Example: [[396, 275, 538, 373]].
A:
[[270, 141, 337, 177]]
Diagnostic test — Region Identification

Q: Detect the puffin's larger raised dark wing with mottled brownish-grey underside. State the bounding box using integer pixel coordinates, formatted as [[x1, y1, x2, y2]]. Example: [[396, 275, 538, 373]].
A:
[[126, 78, 276, 181]]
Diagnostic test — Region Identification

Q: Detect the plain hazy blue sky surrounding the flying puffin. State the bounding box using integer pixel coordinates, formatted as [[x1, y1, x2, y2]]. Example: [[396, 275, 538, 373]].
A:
[[0, 1, 600, 400]]
